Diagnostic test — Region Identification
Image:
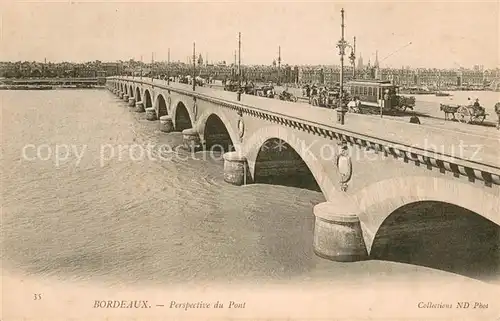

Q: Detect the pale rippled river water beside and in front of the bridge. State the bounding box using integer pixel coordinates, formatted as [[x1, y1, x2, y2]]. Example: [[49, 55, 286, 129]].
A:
[[0, 90, 498, 284]]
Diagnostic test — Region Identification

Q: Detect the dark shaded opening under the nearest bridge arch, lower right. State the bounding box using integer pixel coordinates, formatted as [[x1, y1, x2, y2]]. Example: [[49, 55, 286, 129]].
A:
[[371, 201, 500, 280]]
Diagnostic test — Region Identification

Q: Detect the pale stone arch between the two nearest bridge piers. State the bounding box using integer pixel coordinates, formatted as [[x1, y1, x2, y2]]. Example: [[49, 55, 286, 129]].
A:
[[242, 125, 338, 196]]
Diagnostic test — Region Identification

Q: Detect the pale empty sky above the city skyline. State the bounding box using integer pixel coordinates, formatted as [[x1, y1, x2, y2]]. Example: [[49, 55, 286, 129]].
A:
[[0, 0, 500, 68]]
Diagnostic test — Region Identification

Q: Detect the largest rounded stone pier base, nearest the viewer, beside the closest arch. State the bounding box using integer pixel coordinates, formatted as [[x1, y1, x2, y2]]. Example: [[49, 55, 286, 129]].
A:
[[313, 193, 368, 262]]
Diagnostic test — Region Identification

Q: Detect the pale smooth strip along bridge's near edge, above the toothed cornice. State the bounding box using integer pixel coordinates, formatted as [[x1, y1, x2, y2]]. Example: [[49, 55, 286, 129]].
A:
[[124, 77, 500, 174]]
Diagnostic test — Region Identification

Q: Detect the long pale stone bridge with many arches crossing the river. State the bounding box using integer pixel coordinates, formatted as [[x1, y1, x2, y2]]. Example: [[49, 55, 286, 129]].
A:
[[107, 77, 500, 261]]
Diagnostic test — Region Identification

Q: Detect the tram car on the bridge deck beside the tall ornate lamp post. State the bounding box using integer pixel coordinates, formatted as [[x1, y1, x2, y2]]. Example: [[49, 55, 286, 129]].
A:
[[346, 80, 415, 113]]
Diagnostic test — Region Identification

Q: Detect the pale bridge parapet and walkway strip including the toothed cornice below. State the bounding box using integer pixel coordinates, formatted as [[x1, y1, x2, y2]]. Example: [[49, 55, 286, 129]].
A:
[[109, 77, 500, 186]]
